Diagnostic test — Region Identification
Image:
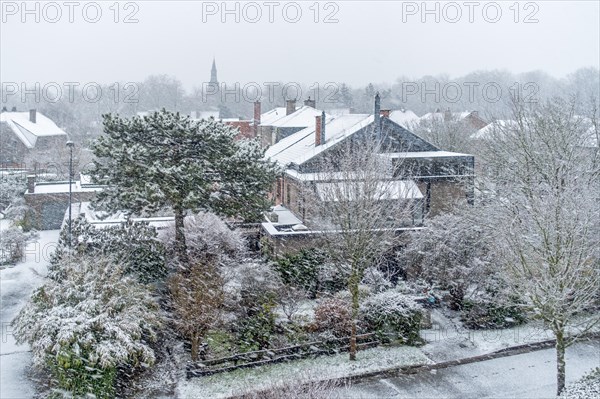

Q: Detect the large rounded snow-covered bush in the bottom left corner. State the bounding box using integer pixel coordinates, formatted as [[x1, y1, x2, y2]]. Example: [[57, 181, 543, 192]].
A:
[[12, 255, 161, 398]]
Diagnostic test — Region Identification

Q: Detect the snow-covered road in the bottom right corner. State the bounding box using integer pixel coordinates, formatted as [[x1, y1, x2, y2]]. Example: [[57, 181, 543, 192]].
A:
[[338, 341, 600, 399]]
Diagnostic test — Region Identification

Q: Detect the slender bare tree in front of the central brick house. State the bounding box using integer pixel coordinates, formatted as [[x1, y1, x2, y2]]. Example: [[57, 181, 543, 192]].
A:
[[309, 138, 422, 360]]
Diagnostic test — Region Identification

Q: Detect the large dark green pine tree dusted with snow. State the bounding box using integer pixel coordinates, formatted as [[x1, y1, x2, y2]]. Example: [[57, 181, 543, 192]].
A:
[[92, 110, 275, 262]]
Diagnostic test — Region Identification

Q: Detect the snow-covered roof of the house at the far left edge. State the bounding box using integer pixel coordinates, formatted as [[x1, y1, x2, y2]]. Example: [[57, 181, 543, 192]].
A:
[[0, 111, 67, 148]]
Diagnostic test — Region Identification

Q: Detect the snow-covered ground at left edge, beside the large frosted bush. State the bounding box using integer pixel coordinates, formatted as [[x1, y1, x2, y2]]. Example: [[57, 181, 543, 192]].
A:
[[0, 228, 59, 398]]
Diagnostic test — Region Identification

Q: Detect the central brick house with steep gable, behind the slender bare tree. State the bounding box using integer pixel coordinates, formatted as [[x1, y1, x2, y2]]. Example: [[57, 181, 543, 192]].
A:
[[263, 96, 474, 250]]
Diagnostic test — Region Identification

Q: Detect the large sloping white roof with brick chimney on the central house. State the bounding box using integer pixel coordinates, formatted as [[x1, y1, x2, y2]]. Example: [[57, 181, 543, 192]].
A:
[[265, 114, 373, 166]]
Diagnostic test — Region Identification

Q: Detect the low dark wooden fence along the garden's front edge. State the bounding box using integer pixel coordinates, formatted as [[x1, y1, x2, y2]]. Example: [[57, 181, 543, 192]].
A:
[[186, 333, 381, 378]]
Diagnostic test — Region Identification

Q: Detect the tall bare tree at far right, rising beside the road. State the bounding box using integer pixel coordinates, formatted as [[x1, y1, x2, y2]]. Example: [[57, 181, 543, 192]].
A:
[[485, 100, 600, 394]]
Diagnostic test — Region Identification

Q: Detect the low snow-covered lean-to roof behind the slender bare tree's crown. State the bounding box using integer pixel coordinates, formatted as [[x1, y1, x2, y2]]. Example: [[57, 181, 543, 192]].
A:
[[315, 180, 423, 201]]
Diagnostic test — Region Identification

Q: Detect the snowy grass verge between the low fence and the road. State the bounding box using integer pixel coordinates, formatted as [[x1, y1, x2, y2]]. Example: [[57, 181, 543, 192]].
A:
[[177, 346, 431, 399]]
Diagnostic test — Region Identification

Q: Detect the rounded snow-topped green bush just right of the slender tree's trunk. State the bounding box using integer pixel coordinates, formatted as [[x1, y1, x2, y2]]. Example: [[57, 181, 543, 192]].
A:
[[360, 291, 422, 345]]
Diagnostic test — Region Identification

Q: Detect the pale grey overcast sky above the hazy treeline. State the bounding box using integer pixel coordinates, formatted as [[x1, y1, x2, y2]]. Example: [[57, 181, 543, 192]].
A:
[[0, 0, 600, 88]]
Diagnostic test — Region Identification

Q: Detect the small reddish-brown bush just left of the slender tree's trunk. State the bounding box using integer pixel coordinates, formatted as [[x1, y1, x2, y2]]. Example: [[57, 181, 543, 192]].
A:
[[315, 297, 352, 337]]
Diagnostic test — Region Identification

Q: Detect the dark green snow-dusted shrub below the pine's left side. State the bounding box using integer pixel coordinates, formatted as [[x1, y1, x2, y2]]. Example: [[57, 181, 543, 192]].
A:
[[52, 216, 167, 283]]
